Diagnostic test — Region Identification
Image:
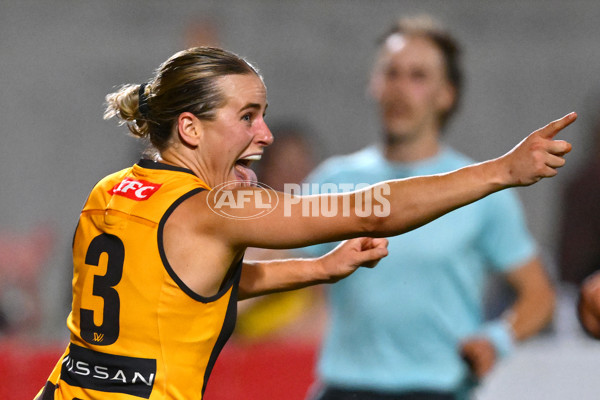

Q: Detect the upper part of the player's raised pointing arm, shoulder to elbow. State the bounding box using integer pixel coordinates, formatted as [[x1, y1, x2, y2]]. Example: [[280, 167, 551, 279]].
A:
[[198, 188, 371, 249]]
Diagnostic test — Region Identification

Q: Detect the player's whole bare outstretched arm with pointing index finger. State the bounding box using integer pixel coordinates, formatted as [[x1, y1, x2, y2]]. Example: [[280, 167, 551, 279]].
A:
[[210, 113, 577, 248]]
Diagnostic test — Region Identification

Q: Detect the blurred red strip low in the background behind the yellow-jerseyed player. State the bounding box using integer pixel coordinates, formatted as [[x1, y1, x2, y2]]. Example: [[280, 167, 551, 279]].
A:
[[0, 339, 317, 400]]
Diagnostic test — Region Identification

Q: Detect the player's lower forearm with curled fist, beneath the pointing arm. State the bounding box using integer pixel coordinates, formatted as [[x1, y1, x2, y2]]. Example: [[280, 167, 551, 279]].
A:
[[238, 237, 388, 300]]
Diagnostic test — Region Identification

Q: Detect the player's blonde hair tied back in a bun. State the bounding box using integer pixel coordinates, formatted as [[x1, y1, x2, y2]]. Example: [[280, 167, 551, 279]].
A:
[[104, 47, 262, 151]]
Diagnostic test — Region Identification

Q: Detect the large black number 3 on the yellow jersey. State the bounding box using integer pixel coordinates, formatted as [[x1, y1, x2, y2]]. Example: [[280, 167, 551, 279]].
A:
[[80, 233, 125, 346]]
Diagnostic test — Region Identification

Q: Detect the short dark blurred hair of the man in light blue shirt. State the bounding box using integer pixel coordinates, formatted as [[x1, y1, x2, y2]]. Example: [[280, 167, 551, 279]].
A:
[[377, 15, 463, 126]]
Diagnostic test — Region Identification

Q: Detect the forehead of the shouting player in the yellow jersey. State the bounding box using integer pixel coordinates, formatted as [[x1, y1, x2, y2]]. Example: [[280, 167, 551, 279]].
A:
[[218, 73, 267, 105]]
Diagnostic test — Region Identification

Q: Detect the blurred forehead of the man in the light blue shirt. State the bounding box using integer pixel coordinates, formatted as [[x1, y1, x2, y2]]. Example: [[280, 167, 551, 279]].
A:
[[377, 34, 445, 71]]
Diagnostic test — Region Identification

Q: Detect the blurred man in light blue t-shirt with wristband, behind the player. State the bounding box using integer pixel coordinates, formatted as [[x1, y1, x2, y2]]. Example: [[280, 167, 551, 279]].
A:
[[306, 16, 555, 400]]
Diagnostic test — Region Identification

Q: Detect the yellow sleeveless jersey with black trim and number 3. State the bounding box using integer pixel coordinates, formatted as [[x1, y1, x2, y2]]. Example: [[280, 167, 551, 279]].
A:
[[38, 160, 241, 400]]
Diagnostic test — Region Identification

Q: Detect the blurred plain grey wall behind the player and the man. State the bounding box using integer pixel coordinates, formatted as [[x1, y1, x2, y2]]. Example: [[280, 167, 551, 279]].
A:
[[0, 0, 600, 398]]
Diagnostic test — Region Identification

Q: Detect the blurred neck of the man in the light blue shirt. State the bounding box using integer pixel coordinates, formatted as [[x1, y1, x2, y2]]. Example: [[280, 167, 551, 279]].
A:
[[383, 133, 440, 163]]
